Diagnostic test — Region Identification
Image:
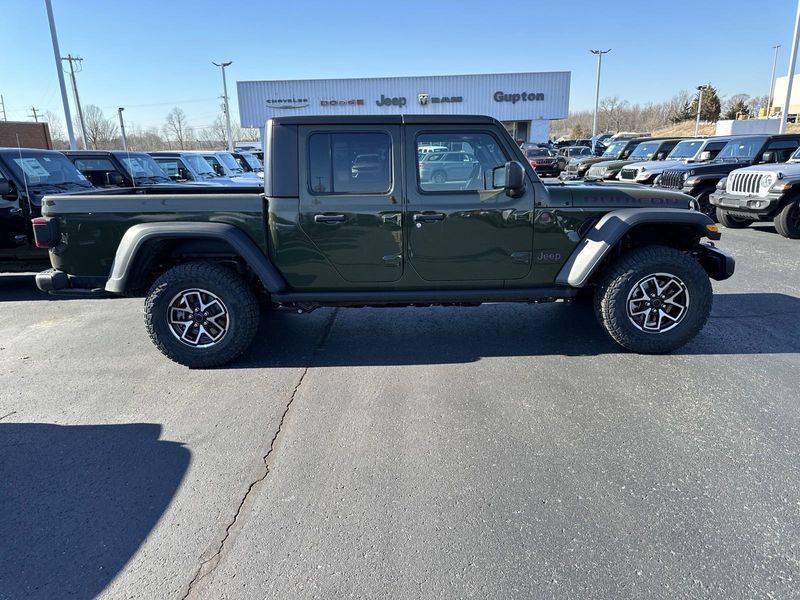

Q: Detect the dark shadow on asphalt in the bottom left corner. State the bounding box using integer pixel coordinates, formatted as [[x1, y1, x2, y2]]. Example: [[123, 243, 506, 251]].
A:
[[0, 423, 191, 598]]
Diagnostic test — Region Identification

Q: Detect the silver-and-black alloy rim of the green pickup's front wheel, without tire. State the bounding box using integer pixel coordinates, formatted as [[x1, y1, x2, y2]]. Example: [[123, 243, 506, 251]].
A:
[[626, 273, 689, 333]]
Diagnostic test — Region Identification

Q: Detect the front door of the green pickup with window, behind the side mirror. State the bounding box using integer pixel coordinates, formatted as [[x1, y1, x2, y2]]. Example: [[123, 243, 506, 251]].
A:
[[405, 125, 533, 282]]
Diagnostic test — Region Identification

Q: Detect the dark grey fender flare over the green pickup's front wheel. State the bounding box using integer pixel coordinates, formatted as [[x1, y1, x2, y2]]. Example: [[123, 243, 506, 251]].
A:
[[556, 208, 719, 287]]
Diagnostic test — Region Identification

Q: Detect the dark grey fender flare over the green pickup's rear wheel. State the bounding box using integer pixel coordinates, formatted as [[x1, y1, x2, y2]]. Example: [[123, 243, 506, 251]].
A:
[[105, 222, 286, 294]]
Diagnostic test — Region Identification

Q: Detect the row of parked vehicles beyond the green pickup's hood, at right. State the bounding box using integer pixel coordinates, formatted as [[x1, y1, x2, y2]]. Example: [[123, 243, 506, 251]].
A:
[[561, 134, 800, 239]]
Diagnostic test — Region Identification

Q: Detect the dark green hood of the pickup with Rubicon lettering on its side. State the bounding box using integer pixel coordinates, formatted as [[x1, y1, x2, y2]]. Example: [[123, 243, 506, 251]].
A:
[[564, 182, 692, 210]]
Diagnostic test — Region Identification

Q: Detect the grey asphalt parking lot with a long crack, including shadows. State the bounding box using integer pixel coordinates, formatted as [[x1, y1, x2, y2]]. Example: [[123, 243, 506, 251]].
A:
[[0, 225, 800, 600]]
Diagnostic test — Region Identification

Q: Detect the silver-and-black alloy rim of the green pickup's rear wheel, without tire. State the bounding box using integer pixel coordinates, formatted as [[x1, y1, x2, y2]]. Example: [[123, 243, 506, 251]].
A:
[[167, 288, 231, 348]]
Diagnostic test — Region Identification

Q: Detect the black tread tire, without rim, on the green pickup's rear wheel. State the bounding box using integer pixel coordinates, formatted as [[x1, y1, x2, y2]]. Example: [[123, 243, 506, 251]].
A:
[[144, 262, 259, 368]]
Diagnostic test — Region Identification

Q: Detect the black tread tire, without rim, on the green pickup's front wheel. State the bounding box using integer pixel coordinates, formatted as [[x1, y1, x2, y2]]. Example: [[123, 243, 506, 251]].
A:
[[594, 246, 713, 354]]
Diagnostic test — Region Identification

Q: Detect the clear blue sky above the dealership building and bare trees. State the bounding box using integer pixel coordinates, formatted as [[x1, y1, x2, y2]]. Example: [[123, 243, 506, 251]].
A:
[[0, 0, 796, 132]]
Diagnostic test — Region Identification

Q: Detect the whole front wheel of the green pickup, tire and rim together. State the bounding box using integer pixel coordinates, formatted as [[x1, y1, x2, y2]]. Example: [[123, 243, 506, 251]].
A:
[[594, 246, 713, 354]]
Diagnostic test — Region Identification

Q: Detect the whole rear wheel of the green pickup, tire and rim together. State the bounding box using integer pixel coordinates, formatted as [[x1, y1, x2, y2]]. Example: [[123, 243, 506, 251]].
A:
[[144, 262, 259, 368]]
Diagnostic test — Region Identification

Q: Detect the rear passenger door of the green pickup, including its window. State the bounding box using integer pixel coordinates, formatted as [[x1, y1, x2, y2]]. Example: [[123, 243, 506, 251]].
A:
[[300, 125, 404, 283]]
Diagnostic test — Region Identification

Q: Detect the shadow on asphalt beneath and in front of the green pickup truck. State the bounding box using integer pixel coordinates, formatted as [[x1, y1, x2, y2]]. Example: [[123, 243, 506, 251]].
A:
[[236, 293, 800, 368]]
